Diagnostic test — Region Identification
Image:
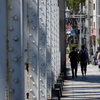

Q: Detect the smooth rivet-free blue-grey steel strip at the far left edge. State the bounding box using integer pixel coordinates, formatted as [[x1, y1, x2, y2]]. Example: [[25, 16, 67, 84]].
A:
[[0, 0, 9, 100]]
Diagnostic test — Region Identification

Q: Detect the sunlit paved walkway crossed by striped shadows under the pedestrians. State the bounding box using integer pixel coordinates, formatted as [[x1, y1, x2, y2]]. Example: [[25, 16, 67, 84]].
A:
[[61, 64, 100, 100]]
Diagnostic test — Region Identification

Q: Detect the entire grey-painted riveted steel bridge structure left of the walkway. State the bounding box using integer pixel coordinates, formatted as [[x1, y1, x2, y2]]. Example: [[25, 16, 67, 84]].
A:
[[0, 0, 61, 100]]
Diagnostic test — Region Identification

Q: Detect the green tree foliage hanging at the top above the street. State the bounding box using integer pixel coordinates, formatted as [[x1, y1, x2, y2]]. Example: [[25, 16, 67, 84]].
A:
[[66, 0, 86, 12]]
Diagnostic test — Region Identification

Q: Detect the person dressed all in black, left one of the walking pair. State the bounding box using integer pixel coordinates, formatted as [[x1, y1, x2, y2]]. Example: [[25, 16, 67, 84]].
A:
[[69, 47, 78, 78]]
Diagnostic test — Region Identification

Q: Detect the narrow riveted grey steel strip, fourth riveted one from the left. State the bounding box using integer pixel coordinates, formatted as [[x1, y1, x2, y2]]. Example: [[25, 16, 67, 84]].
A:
[[46, 0, 51, 98]]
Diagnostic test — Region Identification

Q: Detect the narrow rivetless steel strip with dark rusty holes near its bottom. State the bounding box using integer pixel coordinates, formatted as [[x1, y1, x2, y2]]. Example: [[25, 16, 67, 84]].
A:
[[22, 0, 29, 100]]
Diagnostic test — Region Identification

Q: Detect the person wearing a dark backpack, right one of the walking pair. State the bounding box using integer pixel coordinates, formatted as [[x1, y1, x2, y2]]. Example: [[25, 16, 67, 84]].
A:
[[79, 45, 89, 78]]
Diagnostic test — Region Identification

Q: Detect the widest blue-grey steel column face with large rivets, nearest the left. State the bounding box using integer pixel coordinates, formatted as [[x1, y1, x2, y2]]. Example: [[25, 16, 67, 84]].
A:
[[6, 0, 22, 100]]
